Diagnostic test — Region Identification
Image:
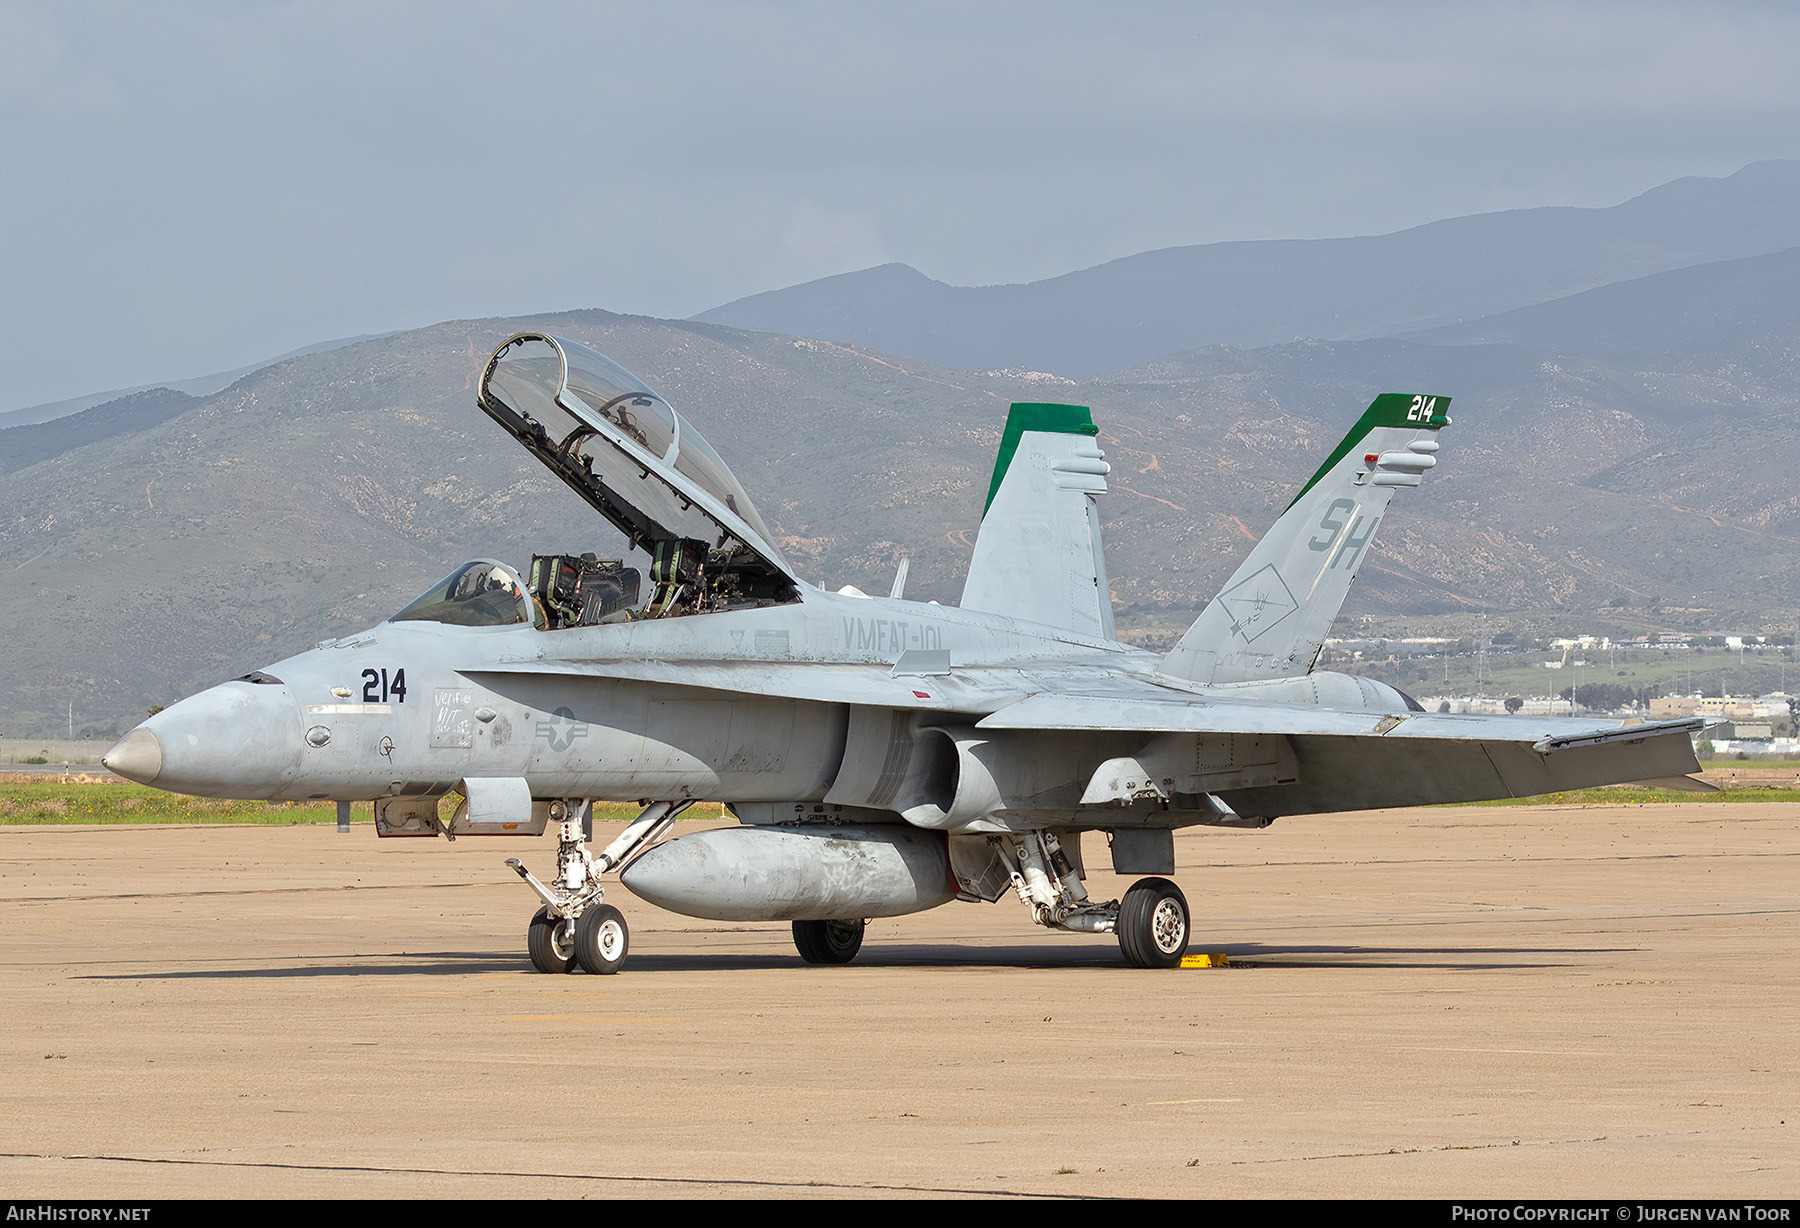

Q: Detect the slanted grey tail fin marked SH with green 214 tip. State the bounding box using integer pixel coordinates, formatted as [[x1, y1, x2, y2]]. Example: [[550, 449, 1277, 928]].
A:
[[1161, 393, 1451, 684]]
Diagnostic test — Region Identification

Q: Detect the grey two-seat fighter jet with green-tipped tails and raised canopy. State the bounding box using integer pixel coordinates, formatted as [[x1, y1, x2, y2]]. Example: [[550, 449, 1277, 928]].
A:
[[103, 333, 1699, 974]]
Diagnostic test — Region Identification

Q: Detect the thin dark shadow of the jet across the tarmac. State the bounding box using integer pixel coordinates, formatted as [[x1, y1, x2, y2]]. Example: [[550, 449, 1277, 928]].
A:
[[77, 944, 1638, 981]]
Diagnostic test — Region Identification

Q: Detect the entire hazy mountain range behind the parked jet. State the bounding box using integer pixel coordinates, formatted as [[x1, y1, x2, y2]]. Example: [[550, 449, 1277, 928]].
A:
[[0, 162, 1800, 735]]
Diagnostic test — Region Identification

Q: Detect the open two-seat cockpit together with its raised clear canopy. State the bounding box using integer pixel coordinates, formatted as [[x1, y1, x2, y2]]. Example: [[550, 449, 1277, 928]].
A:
[[464, 333, 799, 628]]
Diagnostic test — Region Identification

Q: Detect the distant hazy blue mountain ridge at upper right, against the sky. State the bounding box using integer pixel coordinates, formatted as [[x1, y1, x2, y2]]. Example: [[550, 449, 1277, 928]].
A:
[[695, 160, 1800, 376]]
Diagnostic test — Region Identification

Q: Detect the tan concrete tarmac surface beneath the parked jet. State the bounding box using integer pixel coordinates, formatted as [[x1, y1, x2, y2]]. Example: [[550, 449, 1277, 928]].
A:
[[0, 803, 1800, 1201]]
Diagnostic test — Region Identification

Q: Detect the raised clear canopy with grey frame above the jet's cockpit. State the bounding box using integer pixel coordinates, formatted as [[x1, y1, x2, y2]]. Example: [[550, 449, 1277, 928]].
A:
[[477, 333, 794, 600]]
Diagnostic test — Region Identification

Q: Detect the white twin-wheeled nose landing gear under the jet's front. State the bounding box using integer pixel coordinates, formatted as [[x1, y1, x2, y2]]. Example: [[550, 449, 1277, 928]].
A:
[[506, 798, 687, 976]]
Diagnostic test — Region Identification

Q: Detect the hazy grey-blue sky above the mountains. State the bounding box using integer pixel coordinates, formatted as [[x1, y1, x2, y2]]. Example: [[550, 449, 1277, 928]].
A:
[[0, 0, 1800, 411]]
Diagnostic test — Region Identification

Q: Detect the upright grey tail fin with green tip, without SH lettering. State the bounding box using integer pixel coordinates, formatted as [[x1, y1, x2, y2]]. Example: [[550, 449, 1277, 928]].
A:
[[963, 405, 1112, 639]]
